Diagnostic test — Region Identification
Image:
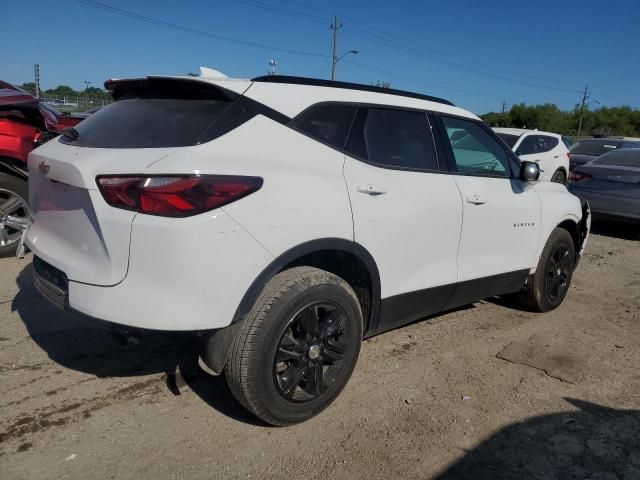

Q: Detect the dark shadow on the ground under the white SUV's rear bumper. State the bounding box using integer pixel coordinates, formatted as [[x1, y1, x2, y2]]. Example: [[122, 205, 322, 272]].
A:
[[11, 264, 266, 426]]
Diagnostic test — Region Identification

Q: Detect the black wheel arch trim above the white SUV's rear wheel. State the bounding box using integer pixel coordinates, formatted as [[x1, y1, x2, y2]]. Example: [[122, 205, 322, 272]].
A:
[[231, 238, 380, 330]]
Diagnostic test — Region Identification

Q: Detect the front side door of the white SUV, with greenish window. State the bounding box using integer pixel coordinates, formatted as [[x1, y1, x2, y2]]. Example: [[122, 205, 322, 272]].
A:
[[437, 115, 541, 307]]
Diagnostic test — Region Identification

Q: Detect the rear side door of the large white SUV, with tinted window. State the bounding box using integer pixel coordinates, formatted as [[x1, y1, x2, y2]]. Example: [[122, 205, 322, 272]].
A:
[[344, 107, 462, 330]]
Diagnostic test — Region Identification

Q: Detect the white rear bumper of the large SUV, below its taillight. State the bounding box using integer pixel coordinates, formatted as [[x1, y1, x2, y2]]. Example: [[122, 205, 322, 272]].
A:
[[29, 211, 273, 331]]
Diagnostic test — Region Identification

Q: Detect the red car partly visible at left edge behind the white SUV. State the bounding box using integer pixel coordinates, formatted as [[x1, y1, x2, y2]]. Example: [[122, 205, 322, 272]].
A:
[[0, 80, 83, 257]]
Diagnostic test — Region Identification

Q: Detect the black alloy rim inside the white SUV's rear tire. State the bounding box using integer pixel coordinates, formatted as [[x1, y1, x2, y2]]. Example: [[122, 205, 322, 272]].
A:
[[273, 302, 353, 402]]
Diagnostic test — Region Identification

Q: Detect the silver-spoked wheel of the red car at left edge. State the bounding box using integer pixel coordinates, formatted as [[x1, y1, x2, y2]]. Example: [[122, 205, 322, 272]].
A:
[[0, 173, 30, 257]]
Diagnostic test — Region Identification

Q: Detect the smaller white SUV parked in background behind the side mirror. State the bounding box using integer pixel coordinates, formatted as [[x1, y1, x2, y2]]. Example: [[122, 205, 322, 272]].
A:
[[493, 128, 571, 184]]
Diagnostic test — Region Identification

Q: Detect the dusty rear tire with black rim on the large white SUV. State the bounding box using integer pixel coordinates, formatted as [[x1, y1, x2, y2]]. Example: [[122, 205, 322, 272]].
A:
[[225, 267, 362, 426]]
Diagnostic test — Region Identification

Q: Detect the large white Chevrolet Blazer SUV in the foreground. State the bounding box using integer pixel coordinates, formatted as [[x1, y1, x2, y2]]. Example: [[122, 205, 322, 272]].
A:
[[24, 71, 589, 425]]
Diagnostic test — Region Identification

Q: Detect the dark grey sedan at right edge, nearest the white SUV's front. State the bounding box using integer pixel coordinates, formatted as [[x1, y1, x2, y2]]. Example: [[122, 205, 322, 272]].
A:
[[568, 148, 640, 223]]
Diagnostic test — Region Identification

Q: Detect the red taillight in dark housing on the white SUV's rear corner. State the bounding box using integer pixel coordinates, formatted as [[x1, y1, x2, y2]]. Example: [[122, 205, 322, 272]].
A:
[[96, 175, 262, 217]]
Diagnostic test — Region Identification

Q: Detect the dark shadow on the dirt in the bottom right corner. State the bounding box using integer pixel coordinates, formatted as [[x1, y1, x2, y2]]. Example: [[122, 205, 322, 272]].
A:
[[436, 398, 640, 480]]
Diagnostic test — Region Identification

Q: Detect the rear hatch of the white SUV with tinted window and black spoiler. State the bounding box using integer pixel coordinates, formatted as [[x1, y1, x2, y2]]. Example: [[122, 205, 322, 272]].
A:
[[27, 77, 252, 286]]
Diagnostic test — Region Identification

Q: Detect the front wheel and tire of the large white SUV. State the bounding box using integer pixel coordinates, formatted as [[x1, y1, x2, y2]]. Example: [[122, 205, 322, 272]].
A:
[[516, 228, 576, 312]]
